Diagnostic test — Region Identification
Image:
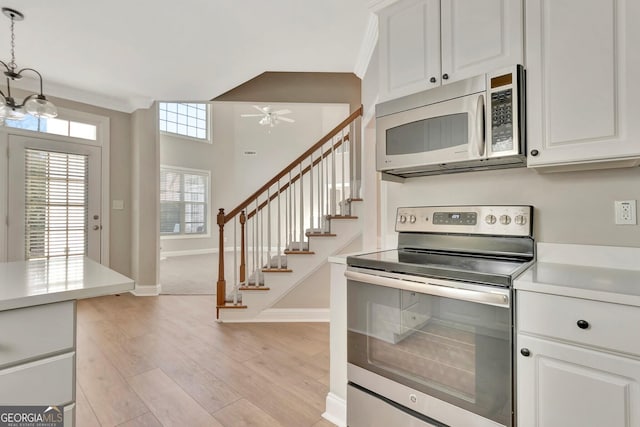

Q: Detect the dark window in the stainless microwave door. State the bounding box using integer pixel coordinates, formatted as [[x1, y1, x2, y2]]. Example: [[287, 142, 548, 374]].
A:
[[386, 113, 469, 155]]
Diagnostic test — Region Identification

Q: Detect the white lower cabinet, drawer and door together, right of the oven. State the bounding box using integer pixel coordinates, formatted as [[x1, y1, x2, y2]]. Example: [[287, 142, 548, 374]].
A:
[[516, 291, 640, 427]]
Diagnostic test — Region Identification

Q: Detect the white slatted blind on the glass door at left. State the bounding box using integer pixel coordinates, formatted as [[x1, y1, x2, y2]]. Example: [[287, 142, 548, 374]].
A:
[[25, 149, 89, 259]]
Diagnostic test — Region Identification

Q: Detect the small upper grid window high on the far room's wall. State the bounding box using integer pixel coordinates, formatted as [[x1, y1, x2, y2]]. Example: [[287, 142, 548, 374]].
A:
[[159, 102, 209, 141]]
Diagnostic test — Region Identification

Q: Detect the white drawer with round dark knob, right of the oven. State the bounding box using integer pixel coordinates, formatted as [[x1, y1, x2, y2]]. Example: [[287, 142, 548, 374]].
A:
[[516, 291, 640, 357]]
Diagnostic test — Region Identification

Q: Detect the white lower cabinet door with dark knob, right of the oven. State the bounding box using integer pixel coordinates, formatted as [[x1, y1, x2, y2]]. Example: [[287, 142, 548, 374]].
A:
[[516, 334, 640, 427]]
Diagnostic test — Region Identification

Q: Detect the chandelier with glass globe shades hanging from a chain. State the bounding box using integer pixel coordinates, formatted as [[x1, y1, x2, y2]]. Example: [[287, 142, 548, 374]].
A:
[[0, 7, 58, 120]]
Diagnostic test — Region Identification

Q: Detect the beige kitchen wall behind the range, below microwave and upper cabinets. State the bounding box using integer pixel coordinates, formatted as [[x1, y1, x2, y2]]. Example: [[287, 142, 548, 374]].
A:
[[380, 167, 640, 247]]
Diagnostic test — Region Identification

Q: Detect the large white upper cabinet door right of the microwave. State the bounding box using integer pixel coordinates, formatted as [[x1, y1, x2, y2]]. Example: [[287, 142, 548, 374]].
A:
[[525, 0, 640, 168]]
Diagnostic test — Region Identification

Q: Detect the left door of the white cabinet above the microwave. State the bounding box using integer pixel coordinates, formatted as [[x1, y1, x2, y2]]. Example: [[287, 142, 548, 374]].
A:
[[379, 0, 440, 101]]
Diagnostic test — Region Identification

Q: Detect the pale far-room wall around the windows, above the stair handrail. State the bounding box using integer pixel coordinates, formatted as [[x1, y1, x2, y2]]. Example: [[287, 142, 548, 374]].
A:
[[160, 102, 349, 252]]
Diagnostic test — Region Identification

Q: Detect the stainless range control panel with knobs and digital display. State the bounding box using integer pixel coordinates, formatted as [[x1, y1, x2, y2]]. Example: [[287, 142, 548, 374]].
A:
[[396, 205, 533, 237]]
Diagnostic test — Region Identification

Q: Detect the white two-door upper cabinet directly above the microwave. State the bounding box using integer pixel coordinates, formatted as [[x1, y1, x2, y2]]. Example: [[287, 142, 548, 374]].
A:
[[378, 0, 523, 101]]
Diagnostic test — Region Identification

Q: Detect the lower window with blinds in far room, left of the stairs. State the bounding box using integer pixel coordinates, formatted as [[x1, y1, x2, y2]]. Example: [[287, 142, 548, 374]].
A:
[[160, 167, 209, 236]]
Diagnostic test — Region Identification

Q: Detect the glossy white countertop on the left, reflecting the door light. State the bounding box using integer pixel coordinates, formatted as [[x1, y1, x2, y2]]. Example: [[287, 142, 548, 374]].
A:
[[0, 257, 134, 311]]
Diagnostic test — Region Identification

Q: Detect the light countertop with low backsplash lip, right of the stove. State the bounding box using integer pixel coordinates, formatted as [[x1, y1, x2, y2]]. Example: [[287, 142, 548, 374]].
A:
[[514, 245, 640, 307]]
